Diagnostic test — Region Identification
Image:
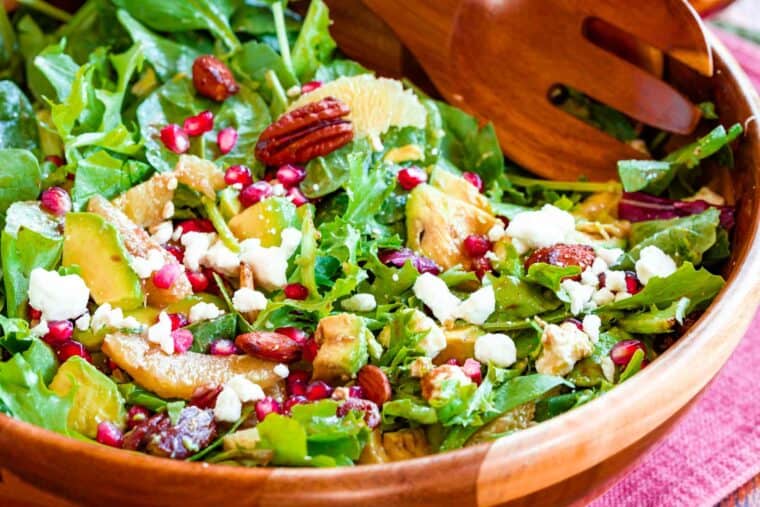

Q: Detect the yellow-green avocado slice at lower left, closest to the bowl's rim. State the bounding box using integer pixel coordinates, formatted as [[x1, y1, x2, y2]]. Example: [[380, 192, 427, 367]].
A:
[[50, 356, 127, 438]]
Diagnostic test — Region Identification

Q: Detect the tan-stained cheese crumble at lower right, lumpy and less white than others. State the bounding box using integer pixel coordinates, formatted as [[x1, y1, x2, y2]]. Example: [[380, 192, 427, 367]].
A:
[[536, 322, 594, 376]]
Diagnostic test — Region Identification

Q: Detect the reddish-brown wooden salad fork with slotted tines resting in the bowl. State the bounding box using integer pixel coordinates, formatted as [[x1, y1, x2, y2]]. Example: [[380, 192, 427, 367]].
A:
[[328, 0, 713, 181]]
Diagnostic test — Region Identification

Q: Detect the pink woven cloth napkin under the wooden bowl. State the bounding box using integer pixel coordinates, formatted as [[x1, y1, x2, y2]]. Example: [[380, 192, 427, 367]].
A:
[[590, 30, 760, 507]]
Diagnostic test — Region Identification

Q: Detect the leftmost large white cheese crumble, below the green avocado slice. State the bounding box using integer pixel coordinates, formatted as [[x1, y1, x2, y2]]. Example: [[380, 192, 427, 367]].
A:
[[28, 268, 90, 321]]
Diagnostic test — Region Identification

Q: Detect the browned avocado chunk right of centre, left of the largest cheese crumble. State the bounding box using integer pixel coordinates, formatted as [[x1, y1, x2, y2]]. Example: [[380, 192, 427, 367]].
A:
[[406, 180, 497, 269]]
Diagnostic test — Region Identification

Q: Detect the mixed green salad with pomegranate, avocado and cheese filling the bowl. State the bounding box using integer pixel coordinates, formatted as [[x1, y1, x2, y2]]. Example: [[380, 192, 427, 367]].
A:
[[0, 0, 742, 467]]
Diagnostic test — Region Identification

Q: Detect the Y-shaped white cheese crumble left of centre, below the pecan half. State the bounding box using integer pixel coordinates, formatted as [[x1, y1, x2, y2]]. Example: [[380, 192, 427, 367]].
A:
[[240, 227, 301, 290]]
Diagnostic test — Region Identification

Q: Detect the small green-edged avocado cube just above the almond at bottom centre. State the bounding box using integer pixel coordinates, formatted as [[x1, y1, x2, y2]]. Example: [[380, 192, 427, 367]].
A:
[[313, 313, 372, 381]]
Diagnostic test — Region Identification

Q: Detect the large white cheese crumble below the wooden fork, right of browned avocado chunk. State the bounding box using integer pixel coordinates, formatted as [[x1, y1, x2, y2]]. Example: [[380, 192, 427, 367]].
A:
[[506, 204, 575, 254]]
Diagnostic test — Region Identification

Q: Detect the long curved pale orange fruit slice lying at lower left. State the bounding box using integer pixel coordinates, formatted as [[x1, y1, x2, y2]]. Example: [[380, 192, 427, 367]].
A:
[[103, 333, 282, 400]]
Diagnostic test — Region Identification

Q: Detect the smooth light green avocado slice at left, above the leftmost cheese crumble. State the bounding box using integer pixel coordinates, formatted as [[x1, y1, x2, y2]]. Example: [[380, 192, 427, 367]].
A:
[[63, 212, 143, 310]]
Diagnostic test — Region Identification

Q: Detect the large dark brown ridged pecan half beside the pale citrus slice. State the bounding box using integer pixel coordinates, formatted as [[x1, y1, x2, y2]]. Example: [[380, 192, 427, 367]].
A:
[[256, 97, 354, 166]]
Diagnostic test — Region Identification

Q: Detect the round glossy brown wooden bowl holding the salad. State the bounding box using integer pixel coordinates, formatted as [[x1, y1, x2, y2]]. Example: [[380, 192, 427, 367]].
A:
[[0, 34, 760, 507]]
